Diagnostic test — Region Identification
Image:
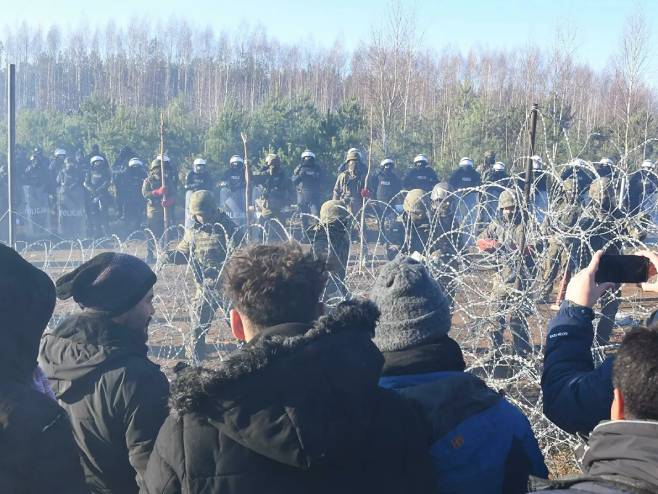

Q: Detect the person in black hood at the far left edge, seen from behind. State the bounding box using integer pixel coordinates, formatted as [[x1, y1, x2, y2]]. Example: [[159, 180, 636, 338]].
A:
[[0, 244, 88, 494]]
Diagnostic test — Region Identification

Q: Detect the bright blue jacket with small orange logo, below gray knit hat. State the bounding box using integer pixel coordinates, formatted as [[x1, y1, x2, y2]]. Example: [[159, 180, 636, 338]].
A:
[[380, 371, 548, 494]]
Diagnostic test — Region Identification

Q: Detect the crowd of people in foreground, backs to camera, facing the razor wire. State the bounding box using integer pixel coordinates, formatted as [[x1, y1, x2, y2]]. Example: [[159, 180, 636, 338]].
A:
[[0, 236, 658, 494]]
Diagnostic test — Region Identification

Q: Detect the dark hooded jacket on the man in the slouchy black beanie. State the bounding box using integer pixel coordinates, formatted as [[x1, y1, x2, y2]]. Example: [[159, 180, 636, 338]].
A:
[[40, 310, 169, 494]]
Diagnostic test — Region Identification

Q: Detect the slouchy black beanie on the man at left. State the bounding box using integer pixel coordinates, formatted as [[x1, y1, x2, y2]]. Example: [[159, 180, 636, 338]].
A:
[[55, 252, 157, 316]]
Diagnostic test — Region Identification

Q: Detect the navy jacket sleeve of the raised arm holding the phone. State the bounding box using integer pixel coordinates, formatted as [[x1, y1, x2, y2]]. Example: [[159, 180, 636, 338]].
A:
[[541, 302, 614, 434]]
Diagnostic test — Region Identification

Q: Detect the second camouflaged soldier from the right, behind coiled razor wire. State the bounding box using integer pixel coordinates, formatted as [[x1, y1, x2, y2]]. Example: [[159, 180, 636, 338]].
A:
[[540, 177, 583, 300]]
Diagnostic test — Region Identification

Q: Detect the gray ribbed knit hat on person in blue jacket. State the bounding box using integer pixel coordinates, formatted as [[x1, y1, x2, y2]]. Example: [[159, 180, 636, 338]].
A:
[[370, 256, 451, 352]]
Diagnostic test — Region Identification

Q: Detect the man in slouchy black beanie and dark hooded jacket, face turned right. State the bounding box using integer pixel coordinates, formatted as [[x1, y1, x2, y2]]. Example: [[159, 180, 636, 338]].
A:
[[40, 252, 169, 494]]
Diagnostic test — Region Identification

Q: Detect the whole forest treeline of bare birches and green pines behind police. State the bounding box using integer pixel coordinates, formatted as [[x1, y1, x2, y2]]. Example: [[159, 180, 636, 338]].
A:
[[0, 4, 658, 178]]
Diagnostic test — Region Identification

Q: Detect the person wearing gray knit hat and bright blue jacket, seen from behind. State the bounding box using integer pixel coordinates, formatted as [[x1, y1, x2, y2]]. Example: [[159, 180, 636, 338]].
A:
[[370, 256, 548, 494]]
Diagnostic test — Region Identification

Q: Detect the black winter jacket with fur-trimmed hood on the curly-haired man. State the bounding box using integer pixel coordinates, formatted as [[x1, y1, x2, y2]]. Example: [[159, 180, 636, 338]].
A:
[[142, 301, 435, 494]]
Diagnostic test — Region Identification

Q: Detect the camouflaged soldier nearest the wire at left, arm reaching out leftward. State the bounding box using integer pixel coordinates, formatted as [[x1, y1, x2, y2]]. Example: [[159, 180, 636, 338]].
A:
[[163, 190, 237, 360]]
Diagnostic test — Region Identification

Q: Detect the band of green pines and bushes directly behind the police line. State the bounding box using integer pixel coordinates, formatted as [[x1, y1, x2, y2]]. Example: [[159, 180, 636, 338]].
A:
[[0, 91, 658, 176]]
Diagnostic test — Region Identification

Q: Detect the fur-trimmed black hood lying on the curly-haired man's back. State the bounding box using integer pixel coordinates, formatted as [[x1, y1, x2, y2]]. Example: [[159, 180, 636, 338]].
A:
[[170, 301, 400, 468]]
